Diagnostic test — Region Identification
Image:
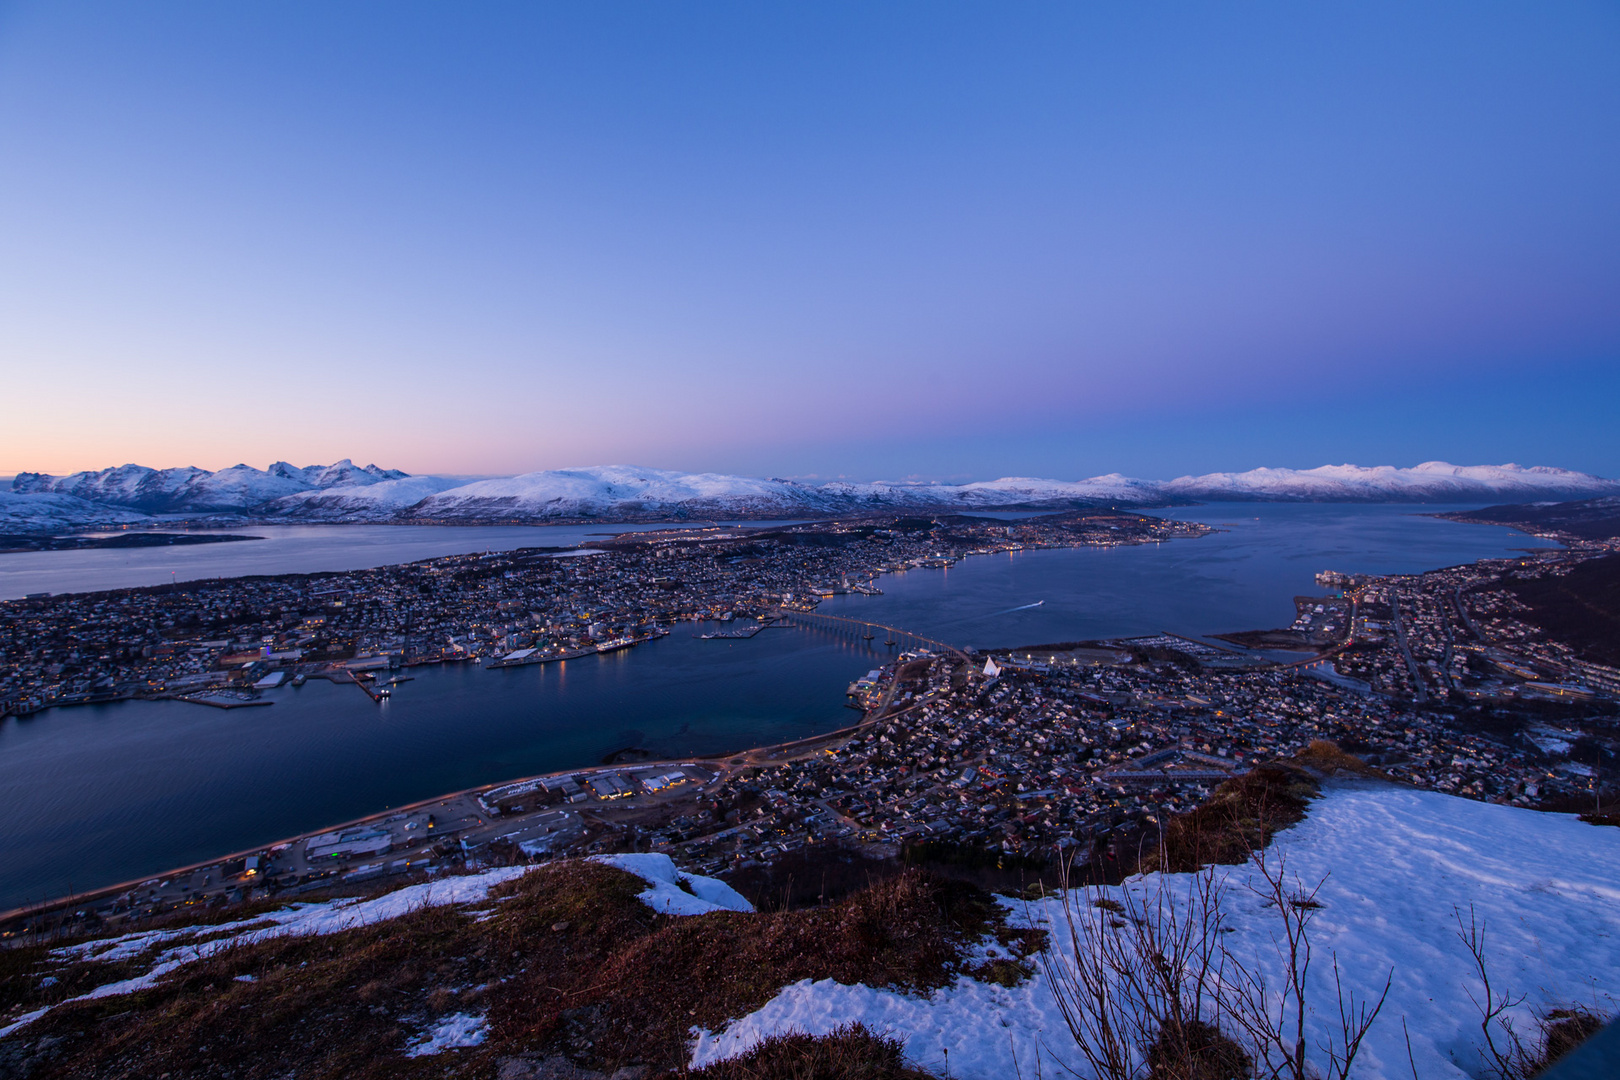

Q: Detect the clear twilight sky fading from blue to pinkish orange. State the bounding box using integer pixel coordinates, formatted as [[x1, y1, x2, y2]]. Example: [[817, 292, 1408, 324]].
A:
[[0, 0, 1620, 481]]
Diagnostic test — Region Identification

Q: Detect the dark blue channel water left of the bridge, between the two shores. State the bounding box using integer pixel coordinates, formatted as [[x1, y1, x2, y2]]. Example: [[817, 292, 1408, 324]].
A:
[[0, 623, 886, 908]]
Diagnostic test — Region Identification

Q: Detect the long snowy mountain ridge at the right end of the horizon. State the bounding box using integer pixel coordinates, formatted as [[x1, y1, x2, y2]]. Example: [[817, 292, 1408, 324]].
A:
[[1160, 461, 1620, 502]]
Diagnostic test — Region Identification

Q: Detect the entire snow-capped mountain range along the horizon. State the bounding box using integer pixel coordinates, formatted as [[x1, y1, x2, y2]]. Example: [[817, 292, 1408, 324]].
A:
[[0, 458, 1620, 533]]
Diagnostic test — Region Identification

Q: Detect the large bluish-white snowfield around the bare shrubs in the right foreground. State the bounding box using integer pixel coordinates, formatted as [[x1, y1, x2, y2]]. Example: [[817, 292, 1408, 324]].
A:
[[692, 787, 1620, 1080]]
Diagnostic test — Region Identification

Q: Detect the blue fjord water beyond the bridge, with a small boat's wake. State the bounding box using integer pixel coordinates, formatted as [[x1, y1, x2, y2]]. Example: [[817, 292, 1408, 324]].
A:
[[816, 504, 1554, 648]]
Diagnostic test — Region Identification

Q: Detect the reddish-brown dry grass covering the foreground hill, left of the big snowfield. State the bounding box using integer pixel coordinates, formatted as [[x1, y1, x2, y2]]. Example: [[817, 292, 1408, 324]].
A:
[[0, 861, 1042, 1080]]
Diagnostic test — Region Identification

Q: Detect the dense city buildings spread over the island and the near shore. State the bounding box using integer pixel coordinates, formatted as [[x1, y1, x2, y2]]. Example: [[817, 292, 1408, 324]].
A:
[[0, 512, 1620, 921]]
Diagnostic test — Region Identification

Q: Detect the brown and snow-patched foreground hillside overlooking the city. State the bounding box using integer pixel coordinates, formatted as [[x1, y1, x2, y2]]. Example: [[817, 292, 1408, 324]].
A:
[[0, 785, 1620, 1080]]
